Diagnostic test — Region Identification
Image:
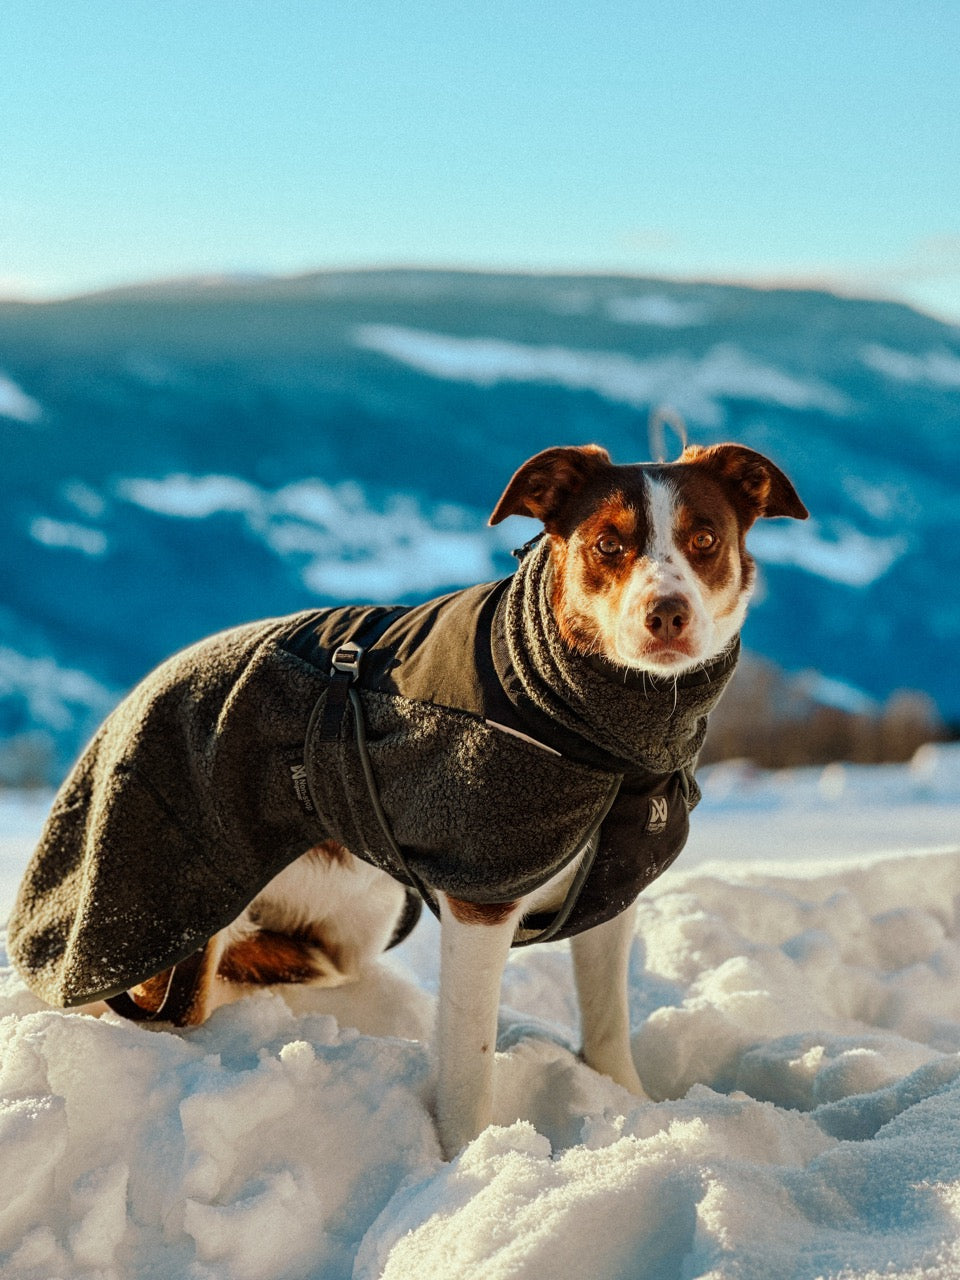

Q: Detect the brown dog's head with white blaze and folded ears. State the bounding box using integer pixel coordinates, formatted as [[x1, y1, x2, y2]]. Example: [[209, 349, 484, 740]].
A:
[[490, 444, 808, 675]]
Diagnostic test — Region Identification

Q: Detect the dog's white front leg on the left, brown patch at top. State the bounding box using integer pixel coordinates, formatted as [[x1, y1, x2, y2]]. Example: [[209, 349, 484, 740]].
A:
[[436, 893, 521, 1158]]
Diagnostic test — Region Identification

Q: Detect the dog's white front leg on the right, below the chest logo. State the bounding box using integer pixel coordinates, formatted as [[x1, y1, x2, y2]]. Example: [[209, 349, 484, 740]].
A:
[[571, 905, 646, 1098]]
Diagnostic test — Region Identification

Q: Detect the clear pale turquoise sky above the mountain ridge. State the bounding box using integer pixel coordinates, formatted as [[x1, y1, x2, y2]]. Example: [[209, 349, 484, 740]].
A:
[[0, 0, 960, 321]]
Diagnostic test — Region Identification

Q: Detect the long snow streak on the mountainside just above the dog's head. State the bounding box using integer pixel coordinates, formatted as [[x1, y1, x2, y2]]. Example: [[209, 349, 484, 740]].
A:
[[355, 324, 852, 426]]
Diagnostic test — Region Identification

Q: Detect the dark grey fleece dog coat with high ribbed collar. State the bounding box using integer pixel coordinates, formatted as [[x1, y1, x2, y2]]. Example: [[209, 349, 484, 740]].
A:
[[8, 543, 739, 1006]]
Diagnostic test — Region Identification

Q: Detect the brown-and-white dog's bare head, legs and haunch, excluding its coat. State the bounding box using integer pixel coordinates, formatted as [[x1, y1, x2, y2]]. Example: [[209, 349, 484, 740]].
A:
[[124, 444, 806, 1156]]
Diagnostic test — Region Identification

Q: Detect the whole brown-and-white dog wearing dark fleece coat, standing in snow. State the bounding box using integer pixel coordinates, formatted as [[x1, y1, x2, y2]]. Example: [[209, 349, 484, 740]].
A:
[[9, 444, 808, 1157]]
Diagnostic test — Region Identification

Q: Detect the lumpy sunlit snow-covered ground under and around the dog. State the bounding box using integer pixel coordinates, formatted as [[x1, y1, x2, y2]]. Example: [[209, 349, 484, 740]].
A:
[[0, 746, 960, 1280]]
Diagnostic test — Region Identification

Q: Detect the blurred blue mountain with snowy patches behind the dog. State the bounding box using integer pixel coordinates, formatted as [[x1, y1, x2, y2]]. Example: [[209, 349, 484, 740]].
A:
[[0, 270, 960, 777]]
